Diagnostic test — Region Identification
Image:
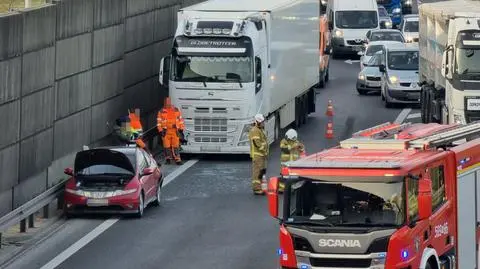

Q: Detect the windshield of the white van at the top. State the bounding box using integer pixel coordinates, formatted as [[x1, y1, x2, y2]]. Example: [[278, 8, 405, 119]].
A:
[[335, 10, 378, 29]]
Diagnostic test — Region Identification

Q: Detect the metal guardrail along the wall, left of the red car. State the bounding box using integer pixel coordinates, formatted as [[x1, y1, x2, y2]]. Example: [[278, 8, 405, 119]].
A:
[[0, 180, 66, 232]]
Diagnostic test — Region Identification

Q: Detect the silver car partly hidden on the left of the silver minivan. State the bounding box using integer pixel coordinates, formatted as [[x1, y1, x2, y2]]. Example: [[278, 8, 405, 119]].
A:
[[357, 50, 384, 95]]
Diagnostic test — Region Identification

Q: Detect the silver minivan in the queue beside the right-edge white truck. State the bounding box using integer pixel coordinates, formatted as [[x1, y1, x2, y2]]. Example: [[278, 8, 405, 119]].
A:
[[378, 43, 420, 107]]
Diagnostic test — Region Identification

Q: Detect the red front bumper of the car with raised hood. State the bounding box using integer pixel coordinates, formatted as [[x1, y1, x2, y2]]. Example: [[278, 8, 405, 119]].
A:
[[65, 193, 139, 214]]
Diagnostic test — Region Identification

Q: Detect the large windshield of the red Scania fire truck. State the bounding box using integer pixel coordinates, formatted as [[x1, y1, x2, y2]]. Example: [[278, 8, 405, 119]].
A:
[[285, 177, 406, 227]]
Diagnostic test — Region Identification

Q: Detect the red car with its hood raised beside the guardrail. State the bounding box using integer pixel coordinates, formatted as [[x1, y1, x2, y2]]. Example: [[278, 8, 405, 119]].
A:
[[65, 144, 163, 217]]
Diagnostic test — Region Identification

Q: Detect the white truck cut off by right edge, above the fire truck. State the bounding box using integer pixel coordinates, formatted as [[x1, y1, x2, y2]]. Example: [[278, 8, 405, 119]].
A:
[[419, 0, 480, 124]]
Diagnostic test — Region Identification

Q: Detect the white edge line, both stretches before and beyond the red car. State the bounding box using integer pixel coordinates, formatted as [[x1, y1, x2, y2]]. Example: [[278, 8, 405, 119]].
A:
[[40, 160, 198, 269]]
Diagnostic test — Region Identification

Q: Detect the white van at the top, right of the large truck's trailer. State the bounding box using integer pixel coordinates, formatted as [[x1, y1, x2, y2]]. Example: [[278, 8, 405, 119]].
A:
[[327, 0, 380, 57]]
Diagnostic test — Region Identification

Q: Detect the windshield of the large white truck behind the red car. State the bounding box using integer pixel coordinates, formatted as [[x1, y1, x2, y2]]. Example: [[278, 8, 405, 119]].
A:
[[172, 56, 253, 82]]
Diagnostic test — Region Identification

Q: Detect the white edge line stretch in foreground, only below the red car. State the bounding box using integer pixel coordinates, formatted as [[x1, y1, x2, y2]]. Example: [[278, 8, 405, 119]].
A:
[[40, 219, 118, 269]]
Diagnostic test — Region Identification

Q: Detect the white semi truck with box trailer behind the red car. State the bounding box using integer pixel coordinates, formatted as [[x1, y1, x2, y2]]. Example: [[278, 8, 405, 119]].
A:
[[159, 0, 320, 154]]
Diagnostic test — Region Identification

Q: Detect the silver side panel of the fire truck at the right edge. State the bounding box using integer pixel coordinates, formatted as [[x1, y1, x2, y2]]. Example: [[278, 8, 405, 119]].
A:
[[457, 169, 480, 268]]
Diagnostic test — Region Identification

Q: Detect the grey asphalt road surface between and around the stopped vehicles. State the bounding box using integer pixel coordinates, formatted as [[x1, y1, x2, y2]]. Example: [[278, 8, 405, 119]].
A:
[[2, 56, 419, 269]]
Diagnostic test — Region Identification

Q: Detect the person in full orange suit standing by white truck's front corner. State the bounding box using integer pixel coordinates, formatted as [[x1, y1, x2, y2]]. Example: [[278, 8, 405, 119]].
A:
[[157, 97, 185, 164]]
